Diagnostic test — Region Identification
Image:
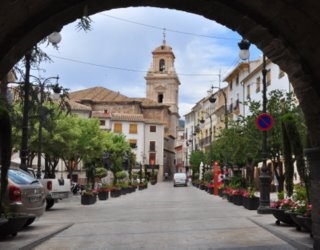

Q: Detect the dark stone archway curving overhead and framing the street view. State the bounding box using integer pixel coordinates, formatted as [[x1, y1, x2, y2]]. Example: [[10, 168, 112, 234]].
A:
[[0, 0, 320, 246]]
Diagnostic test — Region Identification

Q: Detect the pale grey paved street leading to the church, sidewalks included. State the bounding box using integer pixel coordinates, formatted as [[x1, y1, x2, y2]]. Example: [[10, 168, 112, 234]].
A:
[[0, 182, 312, 250]]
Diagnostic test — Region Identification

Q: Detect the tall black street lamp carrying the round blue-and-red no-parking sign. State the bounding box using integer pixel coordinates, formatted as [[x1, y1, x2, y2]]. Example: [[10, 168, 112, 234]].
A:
[[238, 39, 271, 214]]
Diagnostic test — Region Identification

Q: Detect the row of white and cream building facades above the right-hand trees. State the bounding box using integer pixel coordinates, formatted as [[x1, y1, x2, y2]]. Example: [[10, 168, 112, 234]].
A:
[[185, 58, 292, 173]]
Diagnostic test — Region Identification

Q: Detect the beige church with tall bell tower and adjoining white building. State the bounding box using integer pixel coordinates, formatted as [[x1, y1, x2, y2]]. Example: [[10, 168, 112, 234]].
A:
[[70, 40, 180, 181]]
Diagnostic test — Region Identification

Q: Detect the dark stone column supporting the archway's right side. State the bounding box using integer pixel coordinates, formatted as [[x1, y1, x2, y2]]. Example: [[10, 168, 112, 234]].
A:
[[304, 147, 320, 249]]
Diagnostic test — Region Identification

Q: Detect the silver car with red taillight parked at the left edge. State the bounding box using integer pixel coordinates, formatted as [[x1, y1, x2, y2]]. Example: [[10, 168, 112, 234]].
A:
[[0, 168, 46, 226]]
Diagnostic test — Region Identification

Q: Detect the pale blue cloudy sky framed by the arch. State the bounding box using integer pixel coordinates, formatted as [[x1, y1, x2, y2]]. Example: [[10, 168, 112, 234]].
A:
[[32, 7, 262, 119]]
